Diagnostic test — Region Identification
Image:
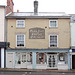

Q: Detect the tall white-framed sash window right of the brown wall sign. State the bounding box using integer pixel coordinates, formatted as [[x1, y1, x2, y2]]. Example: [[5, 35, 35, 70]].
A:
[[49, 35, 58, 47]]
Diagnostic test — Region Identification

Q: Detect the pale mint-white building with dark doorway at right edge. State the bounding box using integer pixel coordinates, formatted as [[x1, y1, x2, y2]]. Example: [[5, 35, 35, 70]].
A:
[[70, 14, 75, 69]]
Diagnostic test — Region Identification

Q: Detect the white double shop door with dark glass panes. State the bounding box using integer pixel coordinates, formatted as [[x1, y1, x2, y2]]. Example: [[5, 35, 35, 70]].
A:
[[47, 54, 57, 68]]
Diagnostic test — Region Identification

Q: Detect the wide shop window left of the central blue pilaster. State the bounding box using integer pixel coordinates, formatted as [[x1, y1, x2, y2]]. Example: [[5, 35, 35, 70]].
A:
[[15, 52, 32, 64]]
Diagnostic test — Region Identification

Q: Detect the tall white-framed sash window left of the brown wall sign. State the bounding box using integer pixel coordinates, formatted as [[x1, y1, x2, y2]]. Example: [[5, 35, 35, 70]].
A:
[[16, 35, 25, 47]]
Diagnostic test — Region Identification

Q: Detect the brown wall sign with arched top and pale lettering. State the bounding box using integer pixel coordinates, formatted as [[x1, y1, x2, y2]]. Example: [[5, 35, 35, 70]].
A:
[[29, 28, 45, 39]]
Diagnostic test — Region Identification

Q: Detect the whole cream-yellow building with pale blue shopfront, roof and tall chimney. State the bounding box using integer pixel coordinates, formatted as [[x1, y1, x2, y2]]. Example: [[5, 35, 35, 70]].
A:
[[6, 1, 70, 69]]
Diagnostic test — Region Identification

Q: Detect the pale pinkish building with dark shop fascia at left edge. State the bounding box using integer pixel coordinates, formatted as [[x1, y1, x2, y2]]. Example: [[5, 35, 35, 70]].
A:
[[0, 5, 6, 68]]
